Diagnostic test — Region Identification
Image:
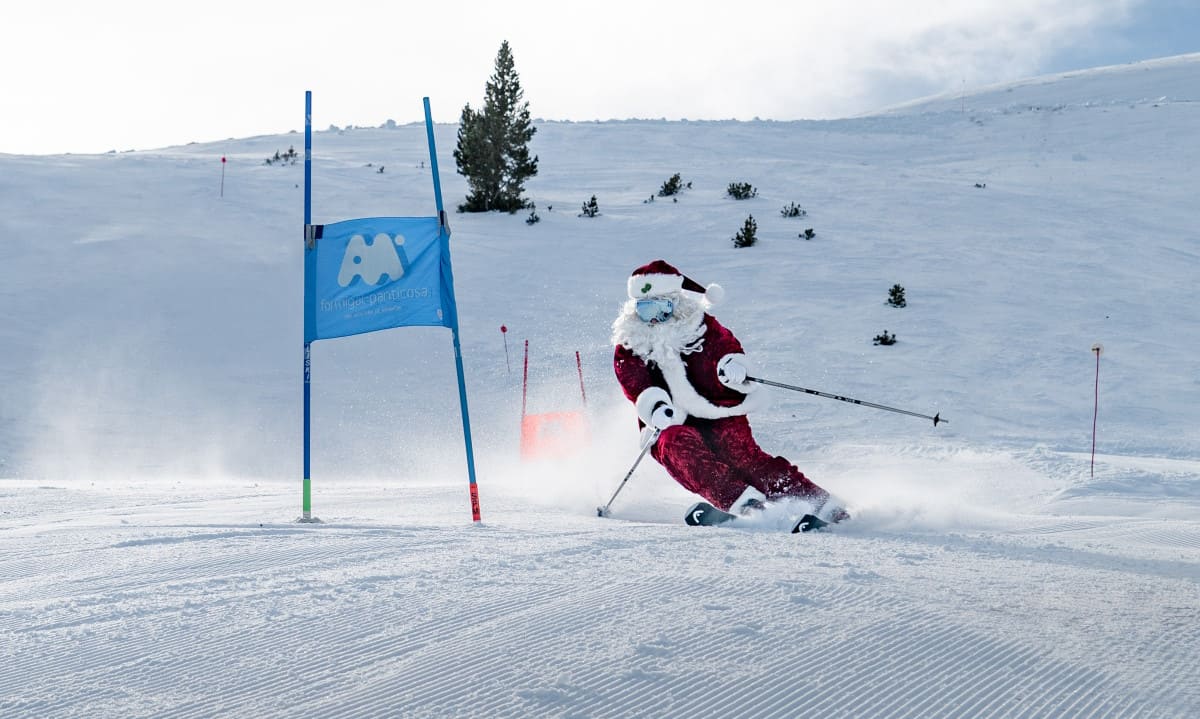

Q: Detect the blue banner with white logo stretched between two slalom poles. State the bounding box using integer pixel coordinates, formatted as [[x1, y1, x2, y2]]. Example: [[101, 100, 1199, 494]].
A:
[[304, 217, 456, 342]]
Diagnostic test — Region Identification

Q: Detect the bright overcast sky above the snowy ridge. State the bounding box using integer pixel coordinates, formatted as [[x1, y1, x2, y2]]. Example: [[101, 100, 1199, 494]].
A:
[[7, 0, 1200, 154]]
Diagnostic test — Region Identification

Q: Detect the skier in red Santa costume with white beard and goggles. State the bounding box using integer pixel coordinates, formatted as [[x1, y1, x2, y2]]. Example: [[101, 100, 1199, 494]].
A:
[[612, 259, 848, 521]]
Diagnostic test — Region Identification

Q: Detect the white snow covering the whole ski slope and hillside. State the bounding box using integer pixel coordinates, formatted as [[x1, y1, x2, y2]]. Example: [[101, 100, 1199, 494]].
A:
[[0, 55, 1200, 719]]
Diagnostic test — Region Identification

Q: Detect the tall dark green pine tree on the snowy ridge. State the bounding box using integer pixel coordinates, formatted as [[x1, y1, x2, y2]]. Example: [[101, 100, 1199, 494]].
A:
[[454, 40, 538, 212]]
